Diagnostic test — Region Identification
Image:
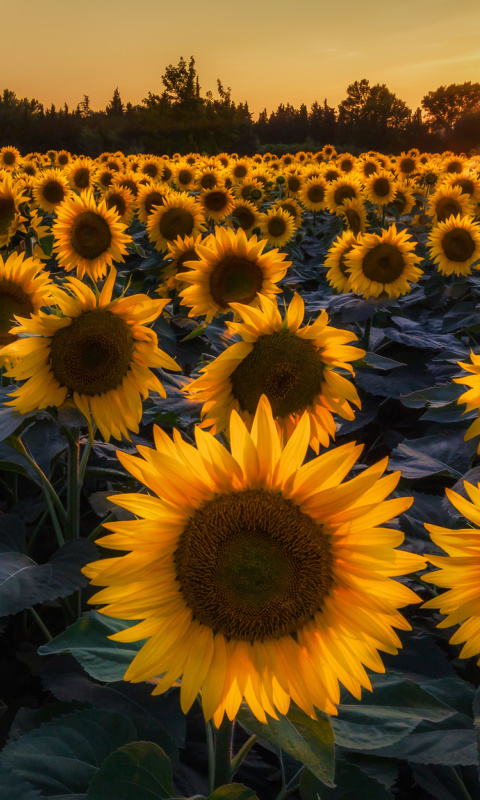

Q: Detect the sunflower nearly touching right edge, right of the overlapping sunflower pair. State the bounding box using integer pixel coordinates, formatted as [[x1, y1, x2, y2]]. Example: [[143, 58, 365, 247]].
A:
[[427, 214, 480, 275]]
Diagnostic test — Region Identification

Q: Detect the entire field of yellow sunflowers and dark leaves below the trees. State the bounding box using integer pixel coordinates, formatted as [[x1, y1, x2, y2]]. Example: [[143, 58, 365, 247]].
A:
[[0, 145, 480, 800]]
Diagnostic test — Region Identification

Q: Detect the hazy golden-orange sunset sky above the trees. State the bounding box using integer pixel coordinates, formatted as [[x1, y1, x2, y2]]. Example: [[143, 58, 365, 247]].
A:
[[0, 0, 480, 119]]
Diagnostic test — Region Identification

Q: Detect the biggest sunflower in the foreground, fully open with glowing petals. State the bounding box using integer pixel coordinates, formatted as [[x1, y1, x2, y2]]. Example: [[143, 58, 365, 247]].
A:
[[83, 397, 425, 727]]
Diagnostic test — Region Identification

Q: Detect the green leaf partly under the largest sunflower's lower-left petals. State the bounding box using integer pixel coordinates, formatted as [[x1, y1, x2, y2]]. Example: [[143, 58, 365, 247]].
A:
[[38, 611, 144, 683]]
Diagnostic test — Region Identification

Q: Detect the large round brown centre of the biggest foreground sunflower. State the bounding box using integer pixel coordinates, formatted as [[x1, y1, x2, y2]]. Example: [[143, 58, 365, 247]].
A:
[[174, 489, 332, 641]]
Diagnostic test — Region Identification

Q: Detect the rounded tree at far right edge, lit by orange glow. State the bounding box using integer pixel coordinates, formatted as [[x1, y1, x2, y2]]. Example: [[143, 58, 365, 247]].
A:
[[422, 81, 480, 133]]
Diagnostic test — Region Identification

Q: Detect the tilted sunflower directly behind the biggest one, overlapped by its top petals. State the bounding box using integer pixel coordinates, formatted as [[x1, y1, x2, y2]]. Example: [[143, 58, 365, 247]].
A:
[[185, 295, 365, 452]]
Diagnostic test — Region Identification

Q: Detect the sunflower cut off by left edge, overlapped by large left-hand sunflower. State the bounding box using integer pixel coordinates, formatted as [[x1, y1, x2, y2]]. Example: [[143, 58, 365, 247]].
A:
[[0, 252, 52, 347]]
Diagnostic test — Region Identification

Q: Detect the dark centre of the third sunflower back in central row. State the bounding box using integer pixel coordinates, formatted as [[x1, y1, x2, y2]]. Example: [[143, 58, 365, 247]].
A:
[[209, 256, 263, 309]]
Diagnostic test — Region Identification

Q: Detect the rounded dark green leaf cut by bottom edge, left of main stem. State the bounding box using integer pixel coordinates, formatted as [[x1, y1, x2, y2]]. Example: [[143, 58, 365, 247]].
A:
[[87, 742, 175, 800]]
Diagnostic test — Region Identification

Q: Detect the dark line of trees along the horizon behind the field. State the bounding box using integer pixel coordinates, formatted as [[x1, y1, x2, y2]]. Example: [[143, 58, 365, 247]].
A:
[[0, 56, 480, 157]]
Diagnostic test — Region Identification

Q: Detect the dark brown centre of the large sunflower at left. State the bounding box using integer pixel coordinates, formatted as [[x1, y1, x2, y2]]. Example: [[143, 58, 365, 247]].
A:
[[51, 308, 134, 395]]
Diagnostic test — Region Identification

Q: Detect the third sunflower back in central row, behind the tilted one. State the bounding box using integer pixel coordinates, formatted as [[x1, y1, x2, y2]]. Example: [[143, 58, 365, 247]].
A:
[[177, 227, 292, 322]]
